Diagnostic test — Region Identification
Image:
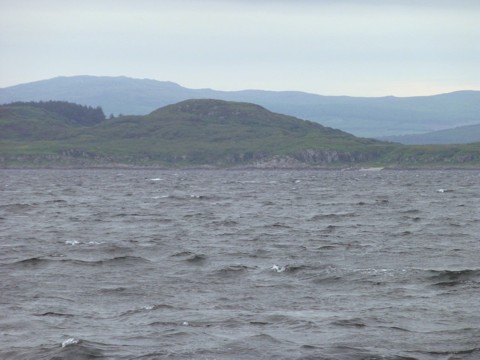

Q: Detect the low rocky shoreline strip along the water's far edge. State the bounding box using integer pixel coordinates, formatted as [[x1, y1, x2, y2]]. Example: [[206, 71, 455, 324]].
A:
[[0, 149, 480, 169]]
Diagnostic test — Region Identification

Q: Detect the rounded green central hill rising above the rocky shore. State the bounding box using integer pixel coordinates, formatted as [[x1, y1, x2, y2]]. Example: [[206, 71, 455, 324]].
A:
[[79, 100, 390, 163]]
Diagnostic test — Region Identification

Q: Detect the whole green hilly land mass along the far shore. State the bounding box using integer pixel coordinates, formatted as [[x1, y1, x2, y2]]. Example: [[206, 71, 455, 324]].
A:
[[0, 99, 480, 167]]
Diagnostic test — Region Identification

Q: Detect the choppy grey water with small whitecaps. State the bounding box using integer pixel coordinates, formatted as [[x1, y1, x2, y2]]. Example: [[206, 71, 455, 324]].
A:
[[0, 170, 480, 359]]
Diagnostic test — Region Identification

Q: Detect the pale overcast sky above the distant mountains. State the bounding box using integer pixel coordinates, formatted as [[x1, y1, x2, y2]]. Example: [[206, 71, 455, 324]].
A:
[[0, 0, 480, 97]]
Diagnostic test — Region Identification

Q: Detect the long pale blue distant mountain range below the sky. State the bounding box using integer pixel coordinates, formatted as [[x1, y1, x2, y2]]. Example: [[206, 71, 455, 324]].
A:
[[0, 76, 480, 143]]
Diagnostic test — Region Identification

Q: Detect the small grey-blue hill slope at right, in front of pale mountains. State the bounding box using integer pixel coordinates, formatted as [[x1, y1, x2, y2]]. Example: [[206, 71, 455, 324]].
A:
[[380, 124, 480, 145]]
